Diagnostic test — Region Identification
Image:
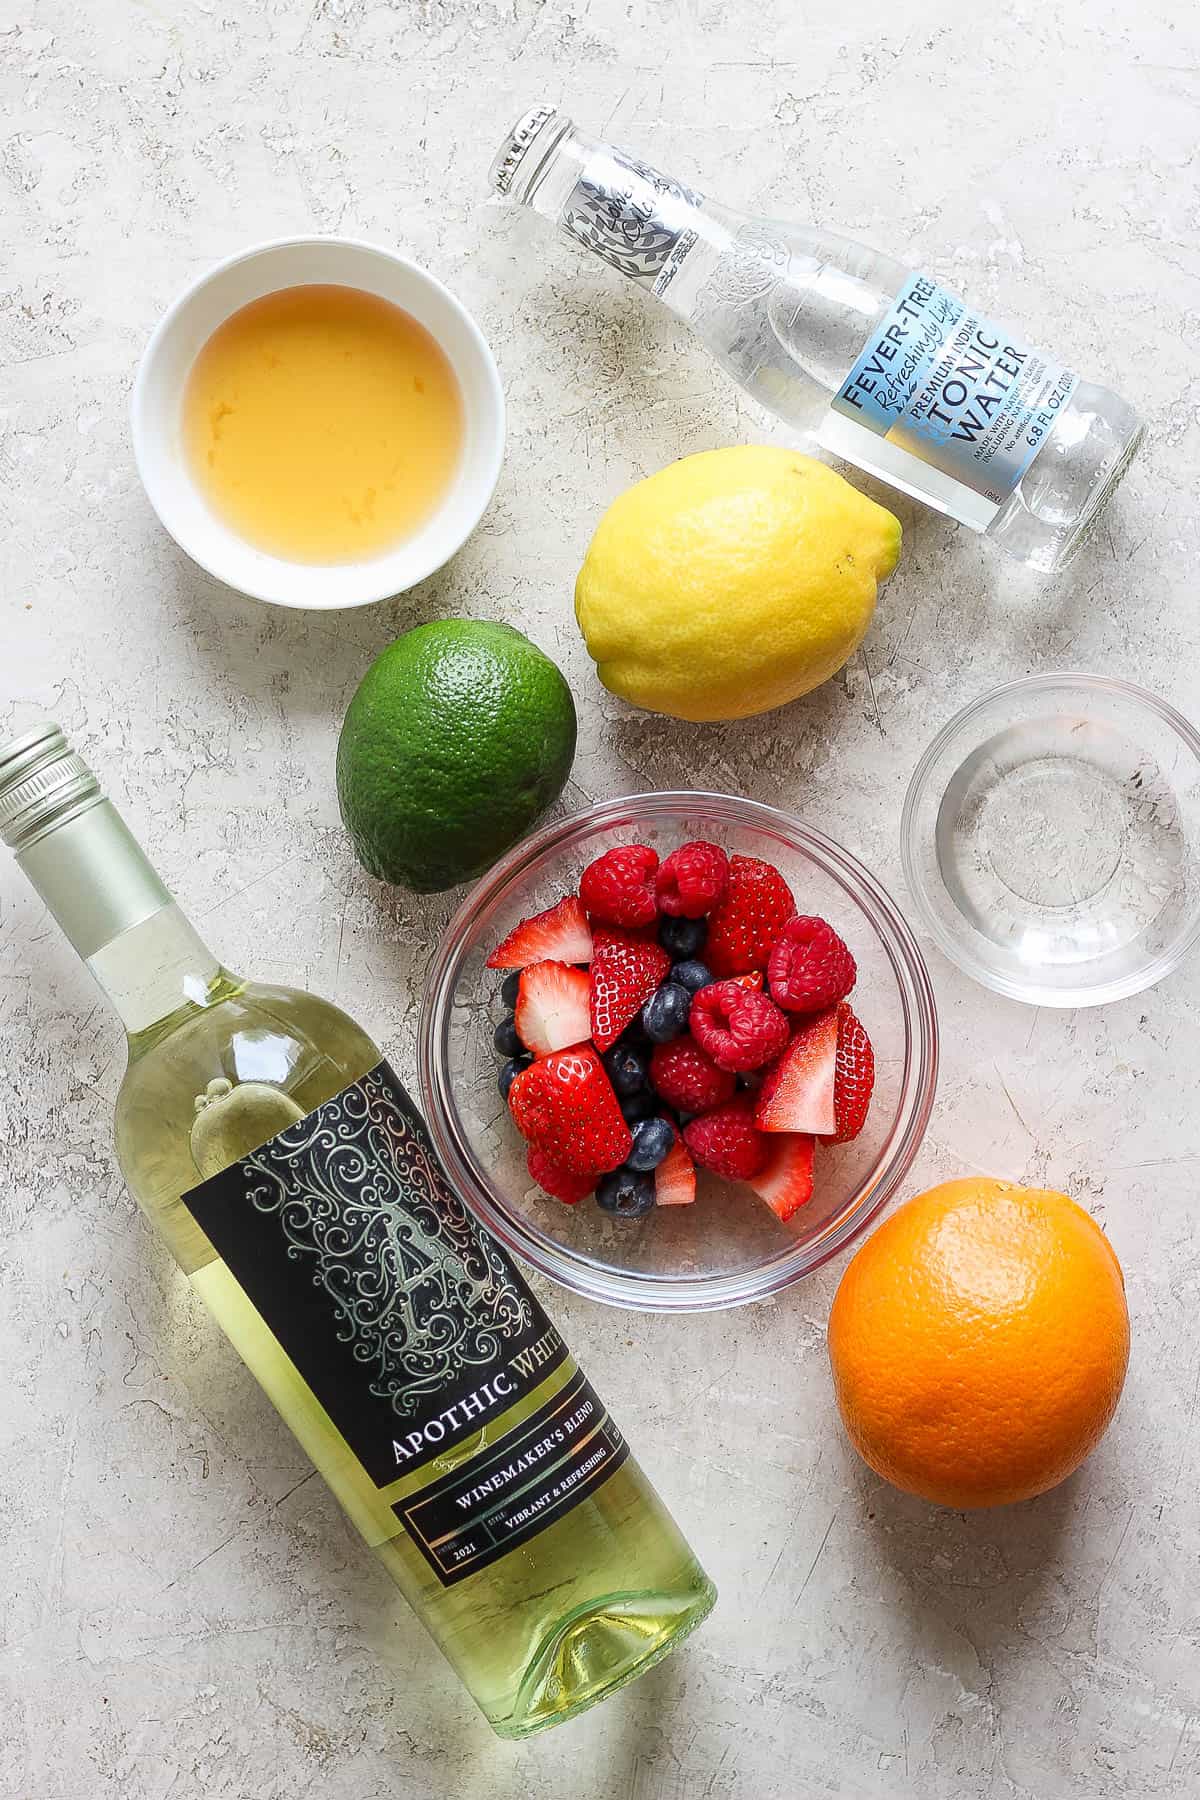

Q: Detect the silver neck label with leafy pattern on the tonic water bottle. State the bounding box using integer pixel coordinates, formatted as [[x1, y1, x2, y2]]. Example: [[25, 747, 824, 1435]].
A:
[[561, 148, 703, 292]]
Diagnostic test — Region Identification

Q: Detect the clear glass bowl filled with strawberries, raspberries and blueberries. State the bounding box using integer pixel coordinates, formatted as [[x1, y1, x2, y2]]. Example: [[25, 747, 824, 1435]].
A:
[[417, 794, 937, 1312]]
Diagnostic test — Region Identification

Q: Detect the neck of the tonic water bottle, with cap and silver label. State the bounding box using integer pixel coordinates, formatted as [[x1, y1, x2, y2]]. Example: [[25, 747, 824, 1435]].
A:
[[491, 106, 703, 299]]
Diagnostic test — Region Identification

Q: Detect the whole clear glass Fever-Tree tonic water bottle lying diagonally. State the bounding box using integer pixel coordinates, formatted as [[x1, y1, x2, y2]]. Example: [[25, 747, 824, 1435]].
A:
[[491, 106, 1142, 572]]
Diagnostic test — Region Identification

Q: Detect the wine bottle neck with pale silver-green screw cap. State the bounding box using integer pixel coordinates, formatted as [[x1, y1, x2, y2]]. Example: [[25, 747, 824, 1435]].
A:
[[0, 725, 221, 1037]]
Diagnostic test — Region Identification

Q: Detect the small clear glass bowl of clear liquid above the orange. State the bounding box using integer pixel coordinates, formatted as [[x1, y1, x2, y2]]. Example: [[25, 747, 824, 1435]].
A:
[[901, 675, 1200, 1006]]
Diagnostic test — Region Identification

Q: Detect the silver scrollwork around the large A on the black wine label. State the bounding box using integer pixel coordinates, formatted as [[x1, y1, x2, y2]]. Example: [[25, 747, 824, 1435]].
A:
[[241, 1071, 533, 1418]]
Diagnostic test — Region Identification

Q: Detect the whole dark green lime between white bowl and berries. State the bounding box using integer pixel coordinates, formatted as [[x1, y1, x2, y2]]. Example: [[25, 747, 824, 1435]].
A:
[[338, 619, 576, 893]]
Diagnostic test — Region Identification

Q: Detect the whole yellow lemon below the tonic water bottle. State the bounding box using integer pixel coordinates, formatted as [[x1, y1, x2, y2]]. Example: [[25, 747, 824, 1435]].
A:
[[576, 445, 900, 720]]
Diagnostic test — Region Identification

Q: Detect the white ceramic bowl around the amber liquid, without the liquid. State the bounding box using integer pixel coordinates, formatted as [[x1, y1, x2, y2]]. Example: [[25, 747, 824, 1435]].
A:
[[133, 238, 504, 610]]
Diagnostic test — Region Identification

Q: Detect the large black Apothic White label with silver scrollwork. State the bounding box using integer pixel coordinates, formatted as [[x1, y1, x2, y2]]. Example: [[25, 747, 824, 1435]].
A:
[[184, 1062, 567, 1487]]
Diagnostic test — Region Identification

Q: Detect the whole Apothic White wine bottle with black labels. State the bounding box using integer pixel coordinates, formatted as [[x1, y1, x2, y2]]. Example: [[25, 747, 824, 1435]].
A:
[[0, 725, 716, 1737]]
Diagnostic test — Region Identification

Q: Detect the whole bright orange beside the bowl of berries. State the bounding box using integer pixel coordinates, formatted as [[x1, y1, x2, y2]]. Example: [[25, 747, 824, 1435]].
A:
[[829, 1179, 1130, 1507]]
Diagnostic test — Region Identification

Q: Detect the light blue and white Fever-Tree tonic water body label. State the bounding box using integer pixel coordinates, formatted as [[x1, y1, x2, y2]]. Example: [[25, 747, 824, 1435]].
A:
[[820, 274, 1078, 531]]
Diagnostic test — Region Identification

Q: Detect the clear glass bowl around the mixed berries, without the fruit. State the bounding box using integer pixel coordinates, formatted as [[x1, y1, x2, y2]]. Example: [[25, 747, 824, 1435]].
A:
[[417, 794, 937, 1312]]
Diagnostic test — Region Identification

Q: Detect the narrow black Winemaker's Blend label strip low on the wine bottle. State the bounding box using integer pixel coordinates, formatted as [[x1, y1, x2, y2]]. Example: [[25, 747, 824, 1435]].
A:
[[394, 1373, 630, 1588]]
